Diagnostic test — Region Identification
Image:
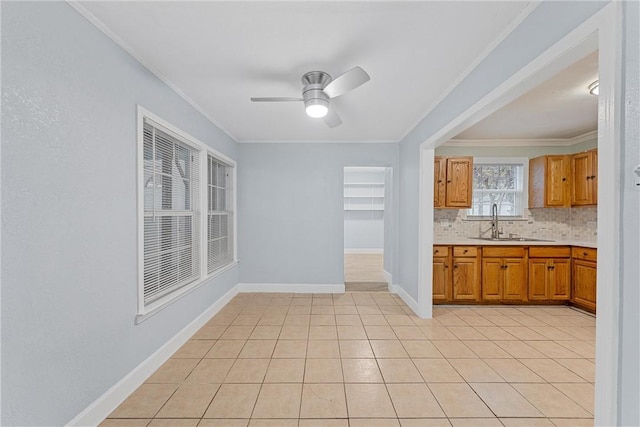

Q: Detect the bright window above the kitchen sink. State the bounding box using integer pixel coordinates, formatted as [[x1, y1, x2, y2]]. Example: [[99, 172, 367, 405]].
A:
[[466, 157, 529, 219]]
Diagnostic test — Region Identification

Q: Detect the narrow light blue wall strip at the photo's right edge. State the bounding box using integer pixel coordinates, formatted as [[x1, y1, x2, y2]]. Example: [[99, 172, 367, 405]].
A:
[[618, 1, 640, 426]]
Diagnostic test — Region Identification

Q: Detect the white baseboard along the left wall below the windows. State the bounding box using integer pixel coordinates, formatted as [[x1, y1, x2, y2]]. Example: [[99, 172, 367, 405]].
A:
[[67, 285, 238, 426]]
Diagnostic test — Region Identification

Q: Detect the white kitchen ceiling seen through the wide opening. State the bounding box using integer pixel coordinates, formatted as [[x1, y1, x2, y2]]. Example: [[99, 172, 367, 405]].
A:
[[454, 52, 598, 140]]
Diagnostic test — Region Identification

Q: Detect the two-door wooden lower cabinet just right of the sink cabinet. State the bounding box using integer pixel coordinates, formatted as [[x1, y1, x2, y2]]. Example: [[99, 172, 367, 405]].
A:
[[528, 246, 571, 301]]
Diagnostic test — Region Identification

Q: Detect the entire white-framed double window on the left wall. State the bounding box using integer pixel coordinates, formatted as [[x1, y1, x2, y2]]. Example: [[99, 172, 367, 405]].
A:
[[136, 107, 236, 323]]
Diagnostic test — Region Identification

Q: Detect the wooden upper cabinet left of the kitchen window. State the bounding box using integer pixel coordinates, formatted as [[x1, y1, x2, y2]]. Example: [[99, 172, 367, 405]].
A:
[[433, 157, 473, 208]]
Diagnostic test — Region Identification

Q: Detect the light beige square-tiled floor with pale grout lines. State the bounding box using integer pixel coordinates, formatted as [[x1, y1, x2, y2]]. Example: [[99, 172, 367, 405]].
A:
[[101, 292, 595, 427]]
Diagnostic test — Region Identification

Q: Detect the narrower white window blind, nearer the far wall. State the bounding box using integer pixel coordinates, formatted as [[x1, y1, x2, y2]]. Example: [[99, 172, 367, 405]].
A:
[[207, 154, 234, 273]]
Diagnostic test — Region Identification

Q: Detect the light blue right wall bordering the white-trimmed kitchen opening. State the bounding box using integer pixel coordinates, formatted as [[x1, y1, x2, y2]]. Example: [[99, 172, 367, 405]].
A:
[[398, 2, 606, 300]]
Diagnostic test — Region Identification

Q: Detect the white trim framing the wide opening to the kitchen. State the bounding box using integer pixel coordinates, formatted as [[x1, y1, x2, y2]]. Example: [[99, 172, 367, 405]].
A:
[[418, 4, 621, 425]]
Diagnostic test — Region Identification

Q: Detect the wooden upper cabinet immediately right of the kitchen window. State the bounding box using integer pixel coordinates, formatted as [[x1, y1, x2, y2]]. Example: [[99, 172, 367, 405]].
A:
[[529, 155, 571, 208]]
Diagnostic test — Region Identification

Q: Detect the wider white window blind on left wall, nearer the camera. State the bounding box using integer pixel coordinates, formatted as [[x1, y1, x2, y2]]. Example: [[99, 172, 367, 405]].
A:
[[143, 119, 200, 306]]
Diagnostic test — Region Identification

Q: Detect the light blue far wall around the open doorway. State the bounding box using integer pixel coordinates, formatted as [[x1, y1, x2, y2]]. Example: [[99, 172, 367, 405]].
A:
[[238, 143, 398, 284]]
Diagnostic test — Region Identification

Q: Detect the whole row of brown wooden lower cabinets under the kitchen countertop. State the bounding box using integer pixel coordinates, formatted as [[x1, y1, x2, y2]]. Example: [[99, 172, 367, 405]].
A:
[[433, 245, 597, 311]]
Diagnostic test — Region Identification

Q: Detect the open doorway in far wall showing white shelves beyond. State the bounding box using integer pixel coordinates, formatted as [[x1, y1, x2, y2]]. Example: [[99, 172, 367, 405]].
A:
[[344, 166, 388, 292]]
